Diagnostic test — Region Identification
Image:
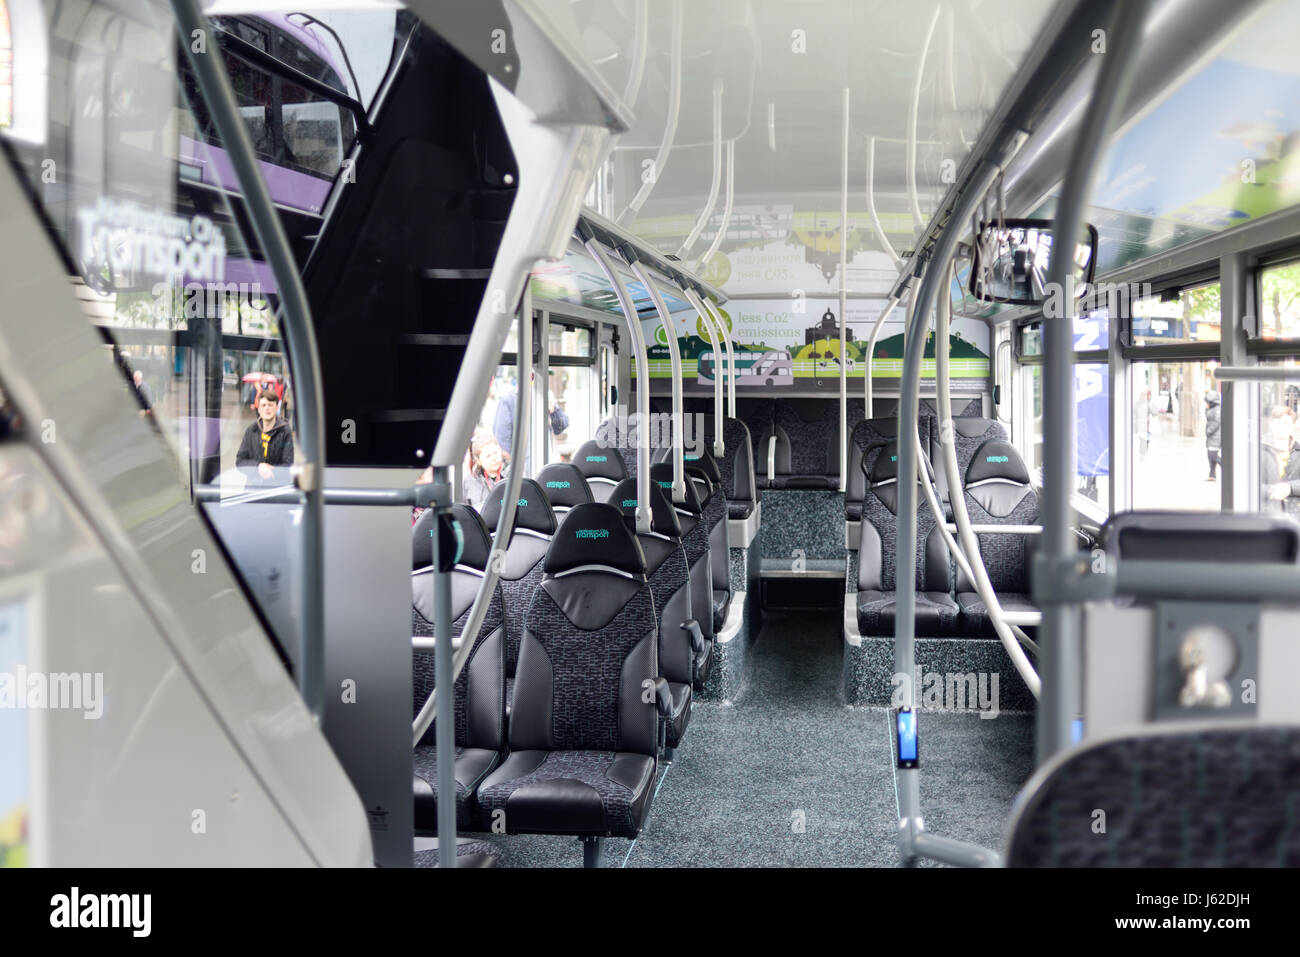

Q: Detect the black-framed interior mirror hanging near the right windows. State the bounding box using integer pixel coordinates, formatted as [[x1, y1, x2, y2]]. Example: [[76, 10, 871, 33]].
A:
[[971, 220, 1097, 306]]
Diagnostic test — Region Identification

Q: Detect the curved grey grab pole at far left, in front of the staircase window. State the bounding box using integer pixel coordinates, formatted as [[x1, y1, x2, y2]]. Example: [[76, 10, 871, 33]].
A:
[[172, 0, 325, 723]]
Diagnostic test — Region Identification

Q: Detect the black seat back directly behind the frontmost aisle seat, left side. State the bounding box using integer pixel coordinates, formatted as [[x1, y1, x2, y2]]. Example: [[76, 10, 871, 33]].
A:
[[610, 479, 694, 684]]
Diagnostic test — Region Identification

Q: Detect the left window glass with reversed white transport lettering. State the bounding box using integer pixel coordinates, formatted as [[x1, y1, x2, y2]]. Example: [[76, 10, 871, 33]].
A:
[[0, 4, 295, 488]]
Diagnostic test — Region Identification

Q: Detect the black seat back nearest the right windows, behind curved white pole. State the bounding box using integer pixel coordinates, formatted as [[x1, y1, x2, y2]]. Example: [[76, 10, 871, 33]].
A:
[[954, 439, 1040, 594]]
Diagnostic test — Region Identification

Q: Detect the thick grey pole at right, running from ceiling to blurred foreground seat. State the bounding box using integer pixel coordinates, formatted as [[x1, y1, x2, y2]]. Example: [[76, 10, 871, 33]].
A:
[[1035, 0, 1149, 766]]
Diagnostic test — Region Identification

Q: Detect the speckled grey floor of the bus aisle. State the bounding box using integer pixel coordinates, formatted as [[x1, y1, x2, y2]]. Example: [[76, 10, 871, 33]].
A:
[[473, 610, 1032, 867]]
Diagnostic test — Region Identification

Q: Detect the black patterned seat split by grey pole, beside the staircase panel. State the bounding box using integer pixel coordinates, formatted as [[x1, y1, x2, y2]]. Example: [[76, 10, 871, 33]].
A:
[[411, 505, 506, 831]]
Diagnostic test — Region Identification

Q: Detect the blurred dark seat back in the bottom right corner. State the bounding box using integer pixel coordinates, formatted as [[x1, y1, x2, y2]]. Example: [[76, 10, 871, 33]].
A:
[[1006, 724, 1300, 867]]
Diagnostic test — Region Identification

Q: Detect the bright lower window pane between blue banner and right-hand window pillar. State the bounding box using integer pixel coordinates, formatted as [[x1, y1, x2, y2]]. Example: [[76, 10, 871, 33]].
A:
[[1130, 361, 1230, 511]]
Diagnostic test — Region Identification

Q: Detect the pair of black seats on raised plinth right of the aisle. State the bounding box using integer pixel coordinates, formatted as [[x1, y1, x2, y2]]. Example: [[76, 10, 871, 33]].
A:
[[845, 416, 1039, 636]]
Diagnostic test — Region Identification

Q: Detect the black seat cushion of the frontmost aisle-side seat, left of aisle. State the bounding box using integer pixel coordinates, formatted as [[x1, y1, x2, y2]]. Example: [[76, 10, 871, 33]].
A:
[[478, 750, 655, 837]]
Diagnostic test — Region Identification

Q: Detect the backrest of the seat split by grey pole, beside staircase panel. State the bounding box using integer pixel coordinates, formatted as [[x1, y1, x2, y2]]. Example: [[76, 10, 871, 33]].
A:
[[411, 505, 506, 750]]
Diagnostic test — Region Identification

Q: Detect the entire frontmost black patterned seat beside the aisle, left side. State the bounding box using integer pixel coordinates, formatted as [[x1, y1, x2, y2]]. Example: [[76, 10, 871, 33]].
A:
[[478, 503, 666, 837]]
